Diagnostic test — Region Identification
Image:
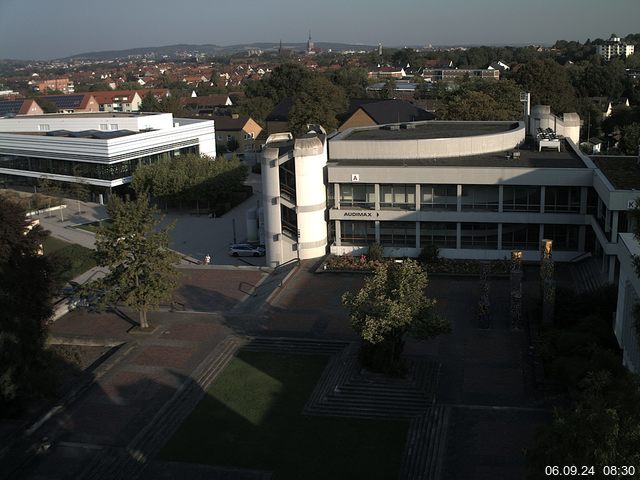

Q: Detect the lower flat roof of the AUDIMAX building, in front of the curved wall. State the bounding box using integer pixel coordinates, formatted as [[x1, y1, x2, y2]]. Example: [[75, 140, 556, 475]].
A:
[[329, 139, 587, 168]]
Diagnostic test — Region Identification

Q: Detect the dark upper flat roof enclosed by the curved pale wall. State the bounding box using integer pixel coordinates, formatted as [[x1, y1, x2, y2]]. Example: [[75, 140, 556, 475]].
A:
[[334, 121, 519, 141]]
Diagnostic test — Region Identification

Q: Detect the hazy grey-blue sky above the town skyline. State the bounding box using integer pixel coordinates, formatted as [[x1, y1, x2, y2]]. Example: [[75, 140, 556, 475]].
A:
[[0, 0, 640, 59]]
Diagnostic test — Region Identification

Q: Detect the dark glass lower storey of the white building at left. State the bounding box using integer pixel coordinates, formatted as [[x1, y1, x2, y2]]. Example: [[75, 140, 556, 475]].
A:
[[0, 146, 199, 180]]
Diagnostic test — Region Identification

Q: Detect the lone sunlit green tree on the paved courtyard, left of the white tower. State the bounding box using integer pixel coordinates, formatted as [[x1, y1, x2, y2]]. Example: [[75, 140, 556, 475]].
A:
[[89, 195, 179, 328]]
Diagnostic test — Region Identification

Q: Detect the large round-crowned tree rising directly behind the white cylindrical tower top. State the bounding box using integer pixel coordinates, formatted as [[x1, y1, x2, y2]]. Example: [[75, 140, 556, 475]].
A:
[[289, 76, 347, 135]]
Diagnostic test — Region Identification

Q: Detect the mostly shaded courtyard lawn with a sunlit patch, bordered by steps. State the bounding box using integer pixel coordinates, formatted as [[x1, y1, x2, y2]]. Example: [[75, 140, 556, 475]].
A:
[[161, 352, 409, 480]]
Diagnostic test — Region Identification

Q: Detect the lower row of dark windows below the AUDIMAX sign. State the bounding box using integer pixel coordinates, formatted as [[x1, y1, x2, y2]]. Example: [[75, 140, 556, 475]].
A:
[[340, 221, 579, 251]]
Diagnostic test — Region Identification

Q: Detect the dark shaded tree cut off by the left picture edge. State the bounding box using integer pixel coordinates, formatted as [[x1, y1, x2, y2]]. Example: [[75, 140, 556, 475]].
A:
[[0, 197, 59, 410]]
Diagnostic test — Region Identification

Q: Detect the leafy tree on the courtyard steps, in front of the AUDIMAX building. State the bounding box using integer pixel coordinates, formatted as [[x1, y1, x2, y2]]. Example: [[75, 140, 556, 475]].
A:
[[342, 260, 450, 373]]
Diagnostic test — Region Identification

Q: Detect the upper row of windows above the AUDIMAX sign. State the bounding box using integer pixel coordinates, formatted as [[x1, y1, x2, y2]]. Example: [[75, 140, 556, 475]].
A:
[[338, 183, 580, 213]]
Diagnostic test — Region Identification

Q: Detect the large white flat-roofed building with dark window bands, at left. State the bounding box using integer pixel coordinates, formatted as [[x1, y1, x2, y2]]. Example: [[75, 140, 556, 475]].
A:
[[0, 113, 216, 193]]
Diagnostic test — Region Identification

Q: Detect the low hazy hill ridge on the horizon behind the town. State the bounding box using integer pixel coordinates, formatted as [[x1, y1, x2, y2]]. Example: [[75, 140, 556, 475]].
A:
[[59, 42, 377, 61]]
